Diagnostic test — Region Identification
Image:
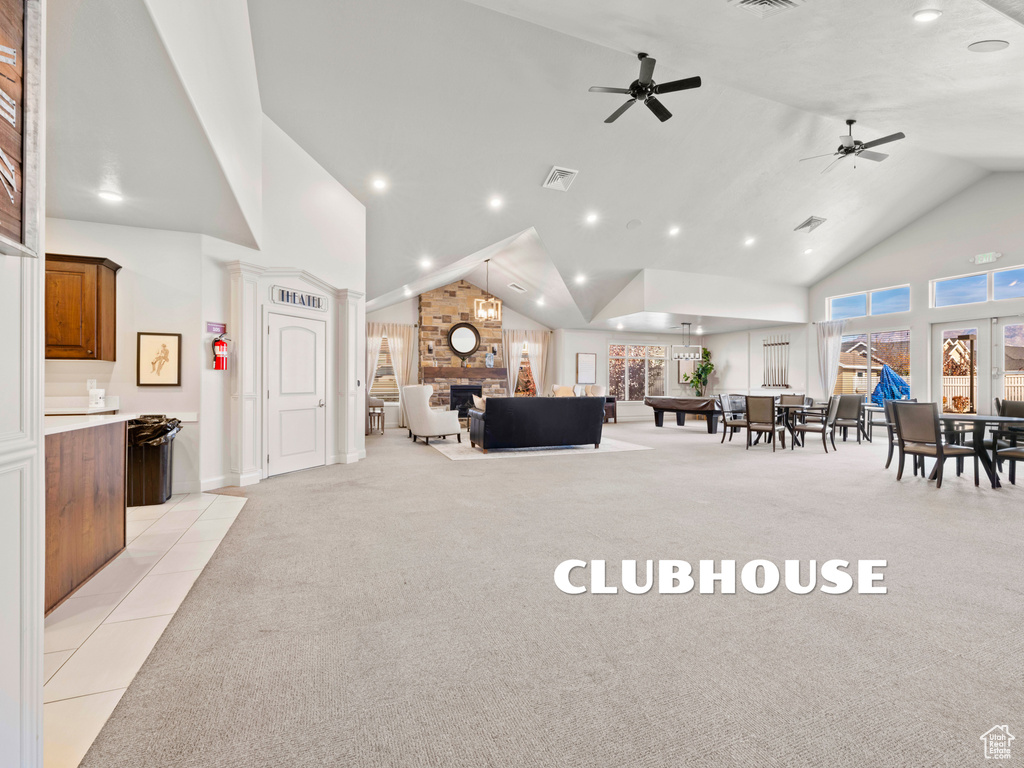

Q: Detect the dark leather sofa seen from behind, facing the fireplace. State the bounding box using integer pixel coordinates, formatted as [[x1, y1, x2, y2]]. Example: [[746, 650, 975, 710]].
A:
[[469, 397, 604, 453]]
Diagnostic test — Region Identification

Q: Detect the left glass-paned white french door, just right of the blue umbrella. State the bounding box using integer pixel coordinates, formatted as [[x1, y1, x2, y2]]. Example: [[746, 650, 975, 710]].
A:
[[932, 317, 993, 414]]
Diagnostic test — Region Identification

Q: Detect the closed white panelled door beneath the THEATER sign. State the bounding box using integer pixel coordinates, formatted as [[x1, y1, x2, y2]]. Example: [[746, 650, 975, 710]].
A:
[[266, 312, 327, 475]]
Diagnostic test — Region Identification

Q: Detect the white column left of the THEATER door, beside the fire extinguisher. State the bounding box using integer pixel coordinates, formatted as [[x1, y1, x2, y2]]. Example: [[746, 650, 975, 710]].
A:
[[227, 261, 264, 485]]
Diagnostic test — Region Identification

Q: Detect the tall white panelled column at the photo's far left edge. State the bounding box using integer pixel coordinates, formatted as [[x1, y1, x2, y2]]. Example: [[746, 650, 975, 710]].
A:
[[0, 0, 46, 768]]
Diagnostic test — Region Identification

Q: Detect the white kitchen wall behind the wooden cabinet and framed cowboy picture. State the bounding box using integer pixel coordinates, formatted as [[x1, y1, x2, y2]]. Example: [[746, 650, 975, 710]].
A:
[[45, 219, 205, 493]]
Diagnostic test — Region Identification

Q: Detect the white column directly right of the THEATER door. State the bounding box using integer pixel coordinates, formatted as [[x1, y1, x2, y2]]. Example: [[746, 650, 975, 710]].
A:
[[335, 290, 367, 456]]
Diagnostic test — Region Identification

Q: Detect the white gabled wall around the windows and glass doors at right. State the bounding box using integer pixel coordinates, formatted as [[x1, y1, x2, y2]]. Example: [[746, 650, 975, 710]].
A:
[[808, 173, 1024, 410]]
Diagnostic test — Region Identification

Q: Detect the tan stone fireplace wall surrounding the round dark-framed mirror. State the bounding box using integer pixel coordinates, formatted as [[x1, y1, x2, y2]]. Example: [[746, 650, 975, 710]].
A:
[[419, 280, 510, 415]]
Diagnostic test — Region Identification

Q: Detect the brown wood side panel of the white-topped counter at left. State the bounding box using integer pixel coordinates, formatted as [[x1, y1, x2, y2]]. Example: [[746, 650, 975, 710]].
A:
[[45, 421, 127, 612]]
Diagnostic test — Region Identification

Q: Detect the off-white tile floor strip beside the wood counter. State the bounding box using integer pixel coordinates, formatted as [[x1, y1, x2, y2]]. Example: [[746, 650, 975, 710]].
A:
[[43, 494, 246, 768]]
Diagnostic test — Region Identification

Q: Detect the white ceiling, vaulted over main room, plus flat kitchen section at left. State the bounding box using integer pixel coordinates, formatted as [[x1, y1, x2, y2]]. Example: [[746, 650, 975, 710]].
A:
[[47, 0, 1024, 327]]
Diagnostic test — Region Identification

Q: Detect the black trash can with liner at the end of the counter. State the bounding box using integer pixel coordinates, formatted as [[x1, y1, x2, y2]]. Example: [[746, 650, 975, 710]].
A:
[[127, 416, 181, 507]]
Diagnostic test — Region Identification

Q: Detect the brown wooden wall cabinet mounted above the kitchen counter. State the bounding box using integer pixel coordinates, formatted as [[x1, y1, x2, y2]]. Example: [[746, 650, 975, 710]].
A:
[[46, 254, 121, 361]]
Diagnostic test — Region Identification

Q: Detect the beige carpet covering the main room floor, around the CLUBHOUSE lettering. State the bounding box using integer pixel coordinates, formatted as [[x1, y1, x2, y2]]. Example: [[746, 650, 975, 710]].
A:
[[84, 421, 1024, 768]]
